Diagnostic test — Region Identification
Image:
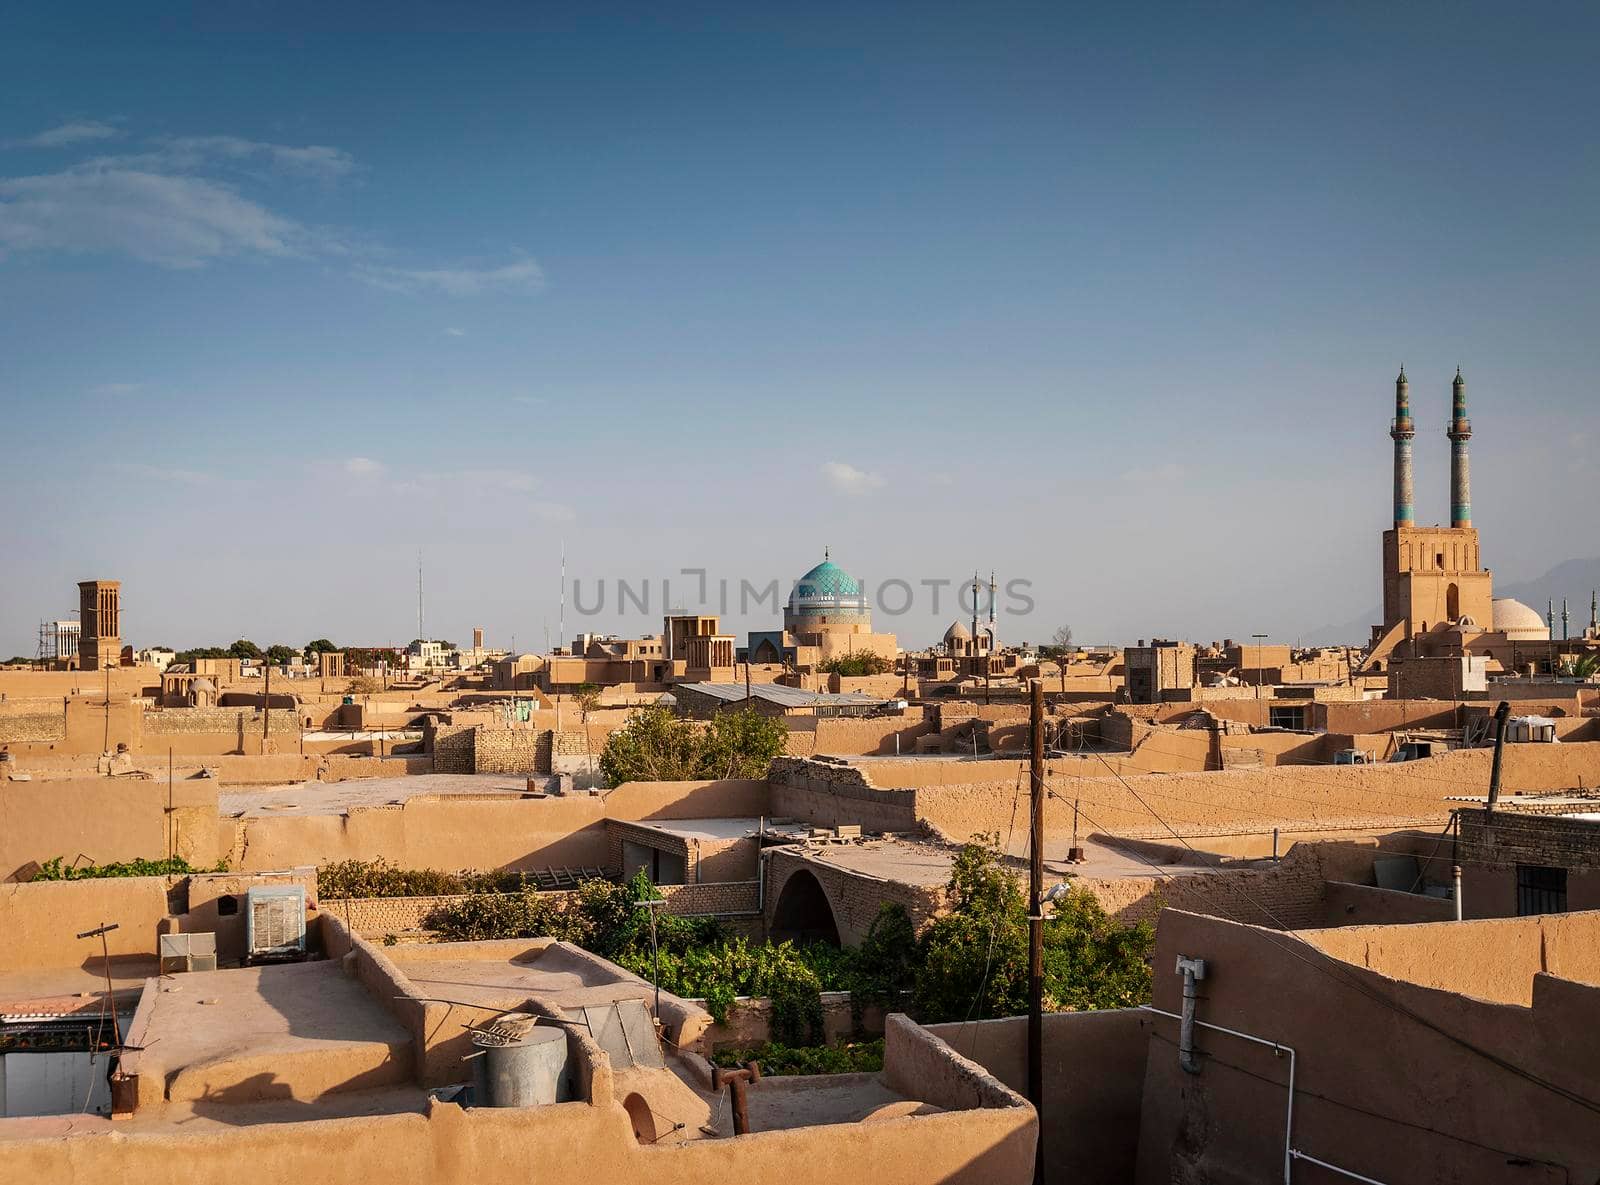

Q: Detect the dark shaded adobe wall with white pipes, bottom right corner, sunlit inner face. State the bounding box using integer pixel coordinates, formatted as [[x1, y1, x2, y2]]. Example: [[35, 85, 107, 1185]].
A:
[[1136, 912, 1600, 1185]]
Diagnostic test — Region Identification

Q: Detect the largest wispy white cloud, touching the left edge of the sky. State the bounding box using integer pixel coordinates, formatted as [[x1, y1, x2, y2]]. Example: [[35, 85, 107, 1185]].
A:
[[0, 168, 322, 267]]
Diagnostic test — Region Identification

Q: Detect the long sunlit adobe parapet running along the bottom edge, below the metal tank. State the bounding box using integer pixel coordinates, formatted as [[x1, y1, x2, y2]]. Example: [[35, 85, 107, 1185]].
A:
[[3, 1044, 1034, 1185]]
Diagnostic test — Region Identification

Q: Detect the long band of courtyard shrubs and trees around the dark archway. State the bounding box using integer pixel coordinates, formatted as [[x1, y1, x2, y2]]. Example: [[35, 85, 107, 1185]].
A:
[[385, 836, 1155, 1042]]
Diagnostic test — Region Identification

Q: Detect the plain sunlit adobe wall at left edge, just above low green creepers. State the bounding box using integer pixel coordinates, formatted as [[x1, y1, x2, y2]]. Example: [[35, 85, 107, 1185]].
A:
[[0, 777, 222, 880]]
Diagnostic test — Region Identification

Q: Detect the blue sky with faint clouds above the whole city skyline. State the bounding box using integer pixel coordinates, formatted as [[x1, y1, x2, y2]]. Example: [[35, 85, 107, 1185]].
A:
[[0, 3, 1600, 654]]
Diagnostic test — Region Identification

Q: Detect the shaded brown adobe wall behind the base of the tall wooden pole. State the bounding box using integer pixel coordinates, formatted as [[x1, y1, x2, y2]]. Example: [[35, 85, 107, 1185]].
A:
[[928, 1007, 1152, 1185]]
